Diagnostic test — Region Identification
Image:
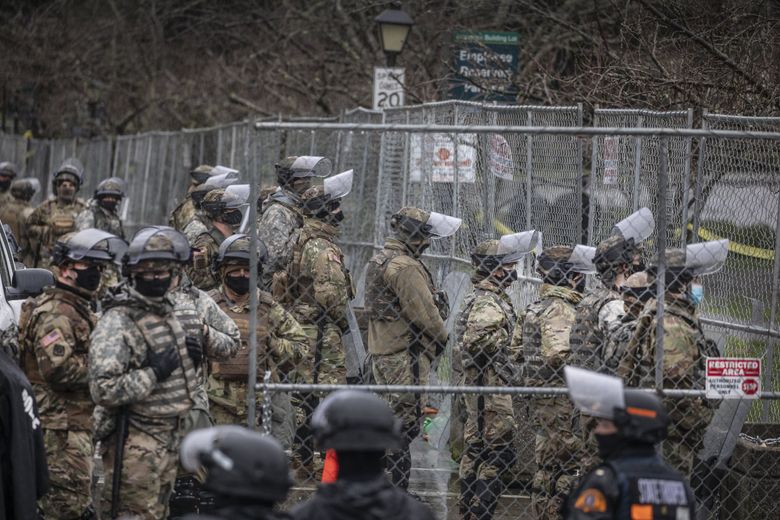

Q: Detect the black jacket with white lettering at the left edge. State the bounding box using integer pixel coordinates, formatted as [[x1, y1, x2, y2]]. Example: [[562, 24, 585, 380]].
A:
[[0, 349, 49, 520]]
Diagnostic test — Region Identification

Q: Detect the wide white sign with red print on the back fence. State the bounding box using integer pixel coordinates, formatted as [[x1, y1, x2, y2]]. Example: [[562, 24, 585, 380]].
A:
[[409, 134, 477, 182]]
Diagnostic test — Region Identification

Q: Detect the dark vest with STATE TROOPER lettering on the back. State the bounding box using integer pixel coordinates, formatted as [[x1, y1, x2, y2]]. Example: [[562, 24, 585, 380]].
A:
[[605, 455, 696, 520]]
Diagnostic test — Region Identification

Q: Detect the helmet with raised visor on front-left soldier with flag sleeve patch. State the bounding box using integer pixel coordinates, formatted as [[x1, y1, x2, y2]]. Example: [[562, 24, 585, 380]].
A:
[[52, 228, 127, 265]]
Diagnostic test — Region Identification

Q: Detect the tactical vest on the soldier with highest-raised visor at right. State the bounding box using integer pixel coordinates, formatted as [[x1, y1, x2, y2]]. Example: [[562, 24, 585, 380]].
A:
[[569, 287, 621, 370]]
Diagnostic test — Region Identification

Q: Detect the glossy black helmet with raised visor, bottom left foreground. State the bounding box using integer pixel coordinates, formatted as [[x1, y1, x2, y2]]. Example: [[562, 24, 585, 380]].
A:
[[180, 425, 293, 503]]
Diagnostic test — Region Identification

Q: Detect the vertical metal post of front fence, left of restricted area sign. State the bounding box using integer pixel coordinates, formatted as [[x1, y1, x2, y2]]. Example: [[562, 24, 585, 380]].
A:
[[655, 136, 669, 390]]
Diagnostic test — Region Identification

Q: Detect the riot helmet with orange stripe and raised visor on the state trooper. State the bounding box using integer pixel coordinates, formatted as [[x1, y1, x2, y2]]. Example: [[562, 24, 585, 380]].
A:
[[564, 366, 669, 445]]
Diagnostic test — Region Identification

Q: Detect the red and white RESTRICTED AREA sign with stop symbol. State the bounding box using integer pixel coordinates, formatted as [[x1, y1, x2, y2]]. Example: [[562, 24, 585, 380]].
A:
[[705, 358, 761, 399]]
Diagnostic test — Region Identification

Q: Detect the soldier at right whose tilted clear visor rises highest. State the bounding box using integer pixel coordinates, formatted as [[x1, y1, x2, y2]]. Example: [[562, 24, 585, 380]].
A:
[[569, 208, 655, 370]]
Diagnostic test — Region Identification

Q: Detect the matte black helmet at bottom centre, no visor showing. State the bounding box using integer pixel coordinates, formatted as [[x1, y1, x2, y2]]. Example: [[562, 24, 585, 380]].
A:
[[311, 390, 401, 451]]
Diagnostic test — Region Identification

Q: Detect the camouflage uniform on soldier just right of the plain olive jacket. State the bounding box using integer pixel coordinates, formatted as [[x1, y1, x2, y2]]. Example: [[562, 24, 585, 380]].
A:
[[456, 280, 518, 518]]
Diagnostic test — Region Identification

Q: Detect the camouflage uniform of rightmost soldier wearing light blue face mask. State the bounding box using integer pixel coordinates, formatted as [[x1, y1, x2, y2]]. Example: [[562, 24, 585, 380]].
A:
[[618, 295, 718, 475]]
